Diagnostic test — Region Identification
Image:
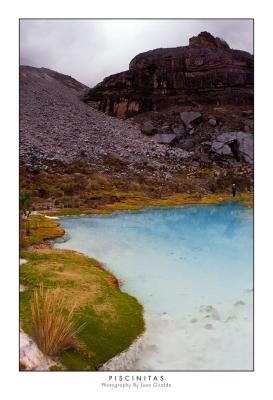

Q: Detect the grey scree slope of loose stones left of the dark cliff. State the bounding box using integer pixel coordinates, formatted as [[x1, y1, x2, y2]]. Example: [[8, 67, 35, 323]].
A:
[[20, 66, 189, 172]]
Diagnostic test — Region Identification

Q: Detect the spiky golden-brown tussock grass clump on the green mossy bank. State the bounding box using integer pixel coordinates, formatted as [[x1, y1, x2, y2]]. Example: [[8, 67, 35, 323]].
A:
[[30, 285, 83, 357]]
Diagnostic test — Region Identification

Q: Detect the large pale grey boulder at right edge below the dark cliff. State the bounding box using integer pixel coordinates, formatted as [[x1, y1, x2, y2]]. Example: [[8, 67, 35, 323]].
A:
[[211, 131, 254, 164]]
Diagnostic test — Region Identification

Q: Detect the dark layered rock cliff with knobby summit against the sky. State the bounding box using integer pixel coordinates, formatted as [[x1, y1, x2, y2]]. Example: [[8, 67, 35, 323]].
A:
[[85, 32, 253, 118]]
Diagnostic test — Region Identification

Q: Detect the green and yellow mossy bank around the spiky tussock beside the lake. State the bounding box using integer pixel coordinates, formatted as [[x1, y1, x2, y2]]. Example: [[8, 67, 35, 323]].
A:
[[20, 216, 144, 371]]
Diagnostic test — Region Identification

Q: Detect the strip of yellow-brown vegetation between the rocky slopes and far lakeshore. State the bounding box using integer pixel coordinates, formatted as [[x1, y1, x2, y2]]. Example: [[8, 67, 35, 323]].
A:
[[20, 162, 253, 215]]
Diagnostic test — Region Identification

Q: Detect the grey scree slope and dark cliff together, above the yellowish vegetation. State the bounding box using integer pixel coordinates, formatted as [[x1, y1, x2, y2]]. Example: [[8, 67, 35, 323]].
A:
[[20, 32, 254, 180]]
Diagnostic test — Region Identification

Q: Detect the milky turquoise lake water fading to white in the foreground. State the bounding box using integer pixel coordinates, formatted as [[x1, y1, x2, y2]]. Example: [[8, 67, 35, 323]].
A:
[[55, 202, 253, 370]]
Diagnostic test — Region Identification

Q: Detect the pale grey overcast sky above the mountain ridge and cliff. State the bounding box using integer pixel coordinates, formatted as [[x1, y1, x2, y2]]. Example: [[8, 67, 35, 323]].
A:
[[20, 20, 253, 87]]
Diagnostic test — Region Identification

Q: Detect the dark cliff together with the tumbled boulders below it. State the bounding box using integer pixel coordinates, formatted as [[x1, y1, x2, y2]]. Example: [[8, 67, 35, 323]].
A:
[[84, 32, 254, 167]]
